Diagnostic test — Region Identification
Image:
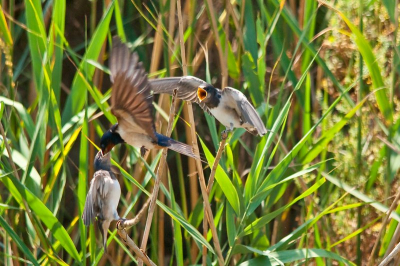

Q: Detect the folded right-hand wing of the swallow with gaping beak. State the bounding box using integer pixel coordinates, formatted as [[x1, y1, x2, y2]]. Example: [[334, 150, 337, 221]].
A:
[[222, 87, 267, 136]]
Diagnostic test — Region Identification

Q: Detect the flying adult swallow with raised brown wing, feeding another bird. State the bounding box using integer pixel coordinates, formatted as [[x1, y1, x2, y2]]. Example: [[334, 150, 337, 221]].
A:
[[100, 37, 197, 158]]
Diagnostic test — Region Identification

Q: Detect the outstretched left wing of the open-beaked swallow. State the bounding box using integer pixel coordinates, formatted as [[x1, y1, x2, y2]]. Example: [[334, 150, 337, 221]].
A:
[[149, 76, 209, 111]]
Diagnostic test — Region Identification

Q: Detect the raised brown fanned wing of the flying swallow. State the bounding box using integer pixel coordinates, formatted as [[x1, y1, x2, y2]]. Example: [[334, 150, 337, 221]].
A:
[[110, 37, 156, 140]]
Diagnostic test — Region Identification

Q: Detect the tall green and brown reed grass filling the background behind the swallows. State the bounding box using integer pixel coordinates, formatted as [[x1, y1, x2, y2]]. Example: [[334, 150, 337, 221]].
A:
[[0, 0, 400, 265]]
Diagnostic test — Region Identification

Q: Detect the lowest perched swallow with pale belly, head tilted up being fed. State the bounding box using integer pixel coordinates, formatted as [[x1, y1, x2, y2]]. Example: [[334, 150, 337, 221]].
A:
[[82, 151, 121, 252]]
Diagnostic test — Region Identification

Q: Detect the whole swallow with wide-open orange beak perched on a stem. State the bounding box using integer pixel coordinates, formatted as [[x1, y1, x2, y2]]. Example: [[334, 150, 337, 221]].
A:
[[149, 76, 268, 136]]
